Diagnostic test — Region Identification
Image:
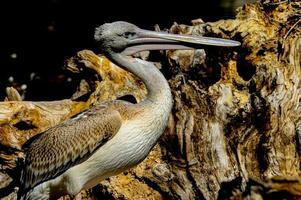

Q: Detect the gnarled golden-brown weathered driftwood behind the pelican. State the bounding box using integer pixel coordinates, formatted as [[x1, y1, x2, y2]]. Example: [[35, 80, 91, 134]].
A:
[[0, 1, 301, 200]]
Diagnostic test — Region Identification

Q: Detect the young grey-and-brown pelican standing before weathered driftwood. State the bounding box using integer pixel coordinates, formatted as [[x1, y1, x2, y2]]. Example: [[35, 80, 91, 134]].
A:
[[18, 21, 240, 200]]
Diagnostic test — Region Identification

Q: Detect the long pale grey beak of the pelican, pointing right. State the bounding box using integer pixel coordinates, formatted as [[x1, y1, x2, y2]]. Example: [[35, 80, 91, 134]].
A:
[[122, 29, 240, 55]]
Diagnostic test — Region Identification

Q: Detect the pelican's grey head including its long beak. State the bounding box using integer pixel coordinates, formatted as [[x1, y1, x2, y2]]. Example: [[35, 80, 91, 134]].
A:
[[94, 21, 240, 55]]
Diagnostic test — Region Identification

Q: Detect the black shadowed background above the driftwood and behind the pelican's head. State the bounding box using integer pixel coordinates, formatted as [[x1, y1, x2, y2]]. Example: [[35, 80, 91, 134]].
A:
[[0, 0, 243, 101]]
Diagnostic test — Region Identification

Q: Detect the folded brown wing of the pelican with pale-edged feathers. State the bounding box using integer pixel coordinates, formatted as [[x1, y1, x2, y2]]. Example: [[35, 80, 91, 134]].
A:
[[21, 105, 122, 192]]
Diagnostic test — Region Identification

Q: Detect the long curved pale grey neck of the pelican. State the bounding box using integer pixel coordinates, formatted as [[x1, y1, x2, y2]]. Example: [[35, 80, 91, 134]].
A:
[[109, 53, 172, 108]]
